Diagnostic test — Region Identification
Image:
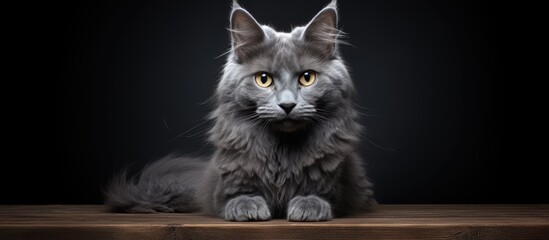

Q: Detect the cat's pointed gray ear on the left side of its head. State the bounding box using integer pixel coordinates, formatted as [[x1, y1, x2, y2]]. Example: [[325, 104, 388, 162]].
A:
[[230, 1, 265, 60]]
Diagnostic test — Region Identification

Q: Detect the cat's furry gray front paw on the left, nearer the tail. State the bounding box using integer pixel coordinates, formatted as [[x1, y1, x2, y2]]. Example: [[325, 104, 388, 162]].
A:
[[225, 196, 271, 222]]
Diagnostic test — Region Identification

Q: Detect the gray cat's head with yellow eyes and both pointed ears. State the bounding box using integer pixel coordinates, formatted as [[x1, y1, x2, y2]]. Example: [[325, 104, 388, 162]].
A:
[[217, 1, 354, 132]]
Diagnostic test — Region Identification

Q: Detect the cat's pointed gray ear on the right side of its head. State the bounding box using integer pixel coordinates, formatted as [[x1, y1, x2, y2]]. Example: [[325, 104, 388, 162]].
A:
[[302, 0, 339, 57]]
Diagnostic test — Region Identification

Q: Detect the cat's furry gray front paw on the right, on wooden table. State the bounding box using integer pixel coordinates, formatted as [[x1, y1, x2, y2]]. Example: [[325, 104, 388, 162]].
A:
[[288, 195, 332, 222]]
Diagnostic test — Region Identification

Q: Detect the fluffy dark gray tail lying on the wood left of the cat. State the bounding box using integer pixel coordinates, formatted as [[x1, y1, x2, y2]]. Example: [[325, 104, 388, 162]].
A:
[[105, 156, 208, 213]]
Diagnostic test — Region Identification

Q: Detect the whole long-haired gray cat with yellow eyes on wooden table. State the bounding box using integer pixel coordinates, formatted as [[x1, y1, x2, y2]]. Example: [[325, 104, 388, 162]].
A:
[[106, 1, 375, 221]]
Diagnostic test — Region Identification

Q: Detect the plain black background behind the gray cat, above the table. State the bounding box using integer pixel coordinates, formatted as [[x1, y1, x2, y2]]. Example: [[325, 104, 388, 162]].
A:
[[0, 0, 549, 204]]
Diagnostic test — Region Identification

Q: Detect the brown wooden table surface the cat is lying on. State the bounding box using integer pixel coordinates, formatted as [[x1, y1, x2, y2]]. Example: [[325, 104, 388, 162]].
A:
[[0, 205, 549, 240]]
